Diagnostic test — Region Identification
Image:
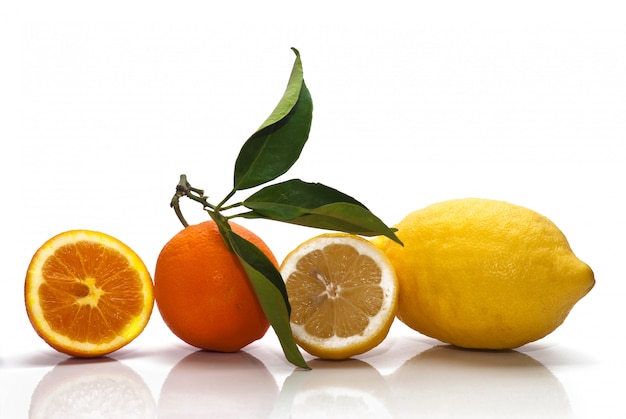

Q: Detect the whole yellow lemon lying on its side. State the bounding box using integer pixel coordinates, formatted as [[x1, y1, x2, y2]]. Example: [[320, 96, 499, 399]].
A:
[[373, 198, 595, 349]]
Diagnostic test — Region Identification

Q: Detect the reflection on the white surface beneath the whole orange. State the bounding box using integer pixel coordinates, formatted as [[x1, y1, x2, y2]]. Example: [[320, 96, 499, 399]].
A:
[[158, 351, 278, 419]]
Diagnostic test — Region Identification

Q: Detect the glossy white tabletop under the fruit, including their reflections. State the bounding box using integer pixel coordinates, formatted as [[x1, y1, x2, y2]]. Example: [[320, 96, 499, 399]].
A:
[[0, 320, 626, 418]]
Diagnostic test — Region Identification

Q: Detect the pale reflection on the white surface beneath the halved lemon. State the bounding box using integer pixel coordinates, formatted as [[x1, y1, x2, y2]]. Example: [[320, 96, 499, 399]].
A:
[[272, 359, 392, 419]]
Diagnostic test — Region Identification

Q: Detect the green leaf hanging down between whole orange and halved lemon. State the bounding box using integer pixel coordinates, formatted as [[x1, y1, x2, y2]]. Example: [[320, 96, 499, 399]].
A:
[[218, 218, 309, 369]]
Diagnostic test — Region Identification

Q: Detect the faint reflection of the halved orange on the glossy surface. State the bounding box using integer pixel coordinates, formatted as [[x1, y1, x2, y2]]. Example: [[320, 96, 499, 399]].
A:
[[29, 358, 156, 419]]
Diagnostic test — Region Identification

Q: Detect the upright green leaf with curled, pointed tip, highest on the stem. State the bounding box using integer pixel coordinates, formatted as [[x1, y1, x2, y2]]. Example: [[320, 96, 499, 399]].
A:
[[234, 48, 313, 190]]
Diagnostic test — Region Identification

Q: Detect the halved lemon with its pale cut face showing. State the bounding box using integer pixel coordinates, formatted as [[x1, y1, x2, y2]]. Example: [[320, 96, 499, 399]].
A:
[[280, 233, 398, 359]]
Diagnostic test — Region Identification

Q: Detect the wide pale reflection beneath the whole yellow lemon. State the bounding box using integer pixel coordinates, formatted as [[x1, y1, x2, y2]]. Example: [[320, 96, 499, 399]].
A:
[[388, 346, 572, 418]]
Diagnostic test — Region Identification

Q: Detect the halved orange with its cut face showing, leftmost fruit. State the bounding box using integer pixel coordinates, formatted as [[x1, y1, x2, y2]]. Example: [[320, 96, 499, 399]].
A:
[[24, 230, 154, 357]]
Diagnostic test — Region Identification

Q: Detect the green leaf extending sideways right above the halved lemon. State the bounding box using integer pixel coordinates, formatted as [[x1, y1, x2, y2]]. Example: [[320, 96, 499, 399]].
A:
[[242, 179, 402, 244]]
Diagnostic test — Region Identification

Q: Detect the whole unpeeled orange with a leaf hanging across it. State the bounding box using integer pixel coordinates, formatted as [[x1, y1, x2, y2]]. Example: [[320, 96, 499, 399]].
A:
[[154, 221, 278, 352]]
